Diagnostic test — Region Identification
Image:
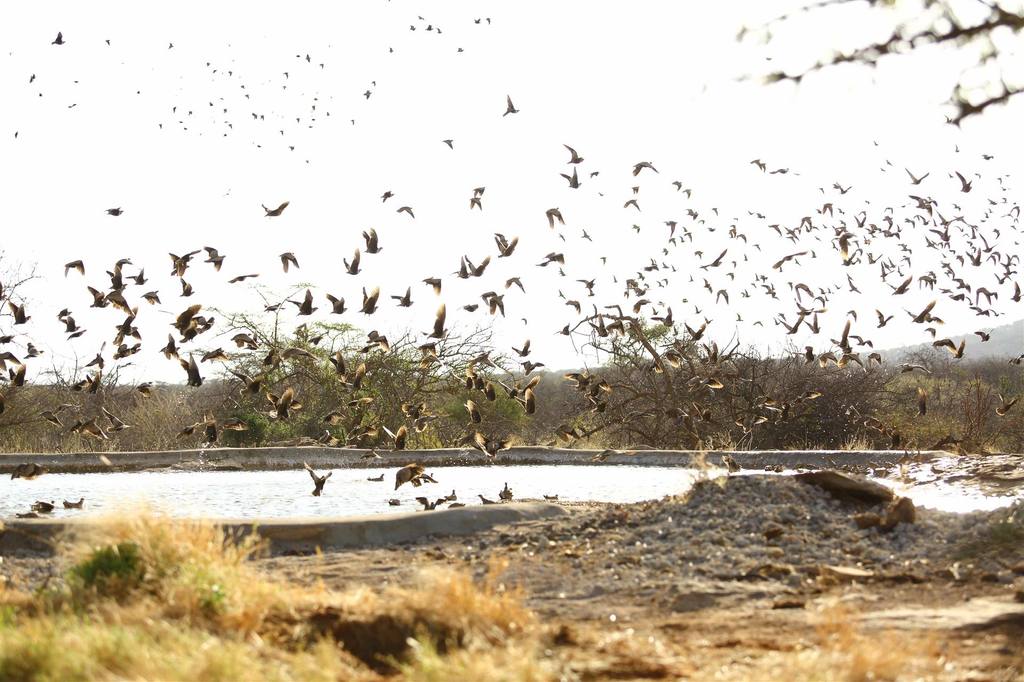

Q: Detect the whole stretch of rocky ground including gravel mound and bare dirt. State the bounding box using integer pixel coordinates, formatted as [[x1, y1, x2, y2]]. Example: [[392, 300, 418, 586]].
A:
[[2, 476, 1024, 680]]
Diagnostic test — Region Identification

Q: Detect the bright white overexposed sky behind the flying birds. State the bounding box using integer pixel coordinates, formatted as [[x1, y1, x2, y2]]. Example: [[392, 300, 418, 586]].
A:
[[0, 0, 1024, 381]]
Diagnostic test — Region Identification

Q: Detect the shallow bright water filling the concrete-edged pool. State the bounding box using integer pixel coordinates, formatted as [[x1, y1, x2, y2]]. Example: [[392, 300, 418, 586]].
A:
[[0, 458, 1024, 518]]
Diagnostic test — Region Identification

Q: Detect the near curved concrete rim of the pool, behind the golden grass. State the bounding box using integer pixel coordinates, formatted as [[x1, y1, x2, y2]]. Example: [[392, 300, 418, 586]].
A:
[[0, 502, 569, 555]]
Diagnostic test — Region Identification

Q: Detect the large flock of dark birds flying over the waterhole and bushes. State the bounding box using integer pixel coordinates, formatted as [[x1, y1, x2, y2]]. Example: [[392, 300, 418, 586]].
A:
[[8, 17, 1024, 513]]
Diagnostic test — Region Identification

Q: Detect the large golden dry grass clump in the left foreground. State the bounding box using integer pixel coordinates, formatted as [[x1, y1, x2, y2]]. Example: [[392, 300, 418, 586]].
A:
[[0, 513, 551, 682]]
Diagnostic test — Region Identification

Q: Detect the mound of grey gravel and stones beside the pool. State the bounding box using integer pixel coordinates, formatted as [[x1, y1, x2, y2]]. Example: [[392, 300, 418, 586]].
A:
[[463, 476, 1024, 593]]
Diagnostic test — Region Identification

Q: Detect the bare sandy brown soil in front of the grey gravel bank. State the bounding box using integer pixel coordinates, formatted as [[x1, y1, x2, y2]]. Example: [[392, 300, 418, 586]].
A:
[[251, 543, 1024, 680]]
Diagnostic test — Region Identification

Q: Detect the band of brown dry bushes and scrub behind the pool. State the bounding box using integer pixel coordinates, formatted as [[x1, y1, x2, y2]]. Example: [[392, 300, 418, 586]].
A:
[[0, 319, 1024, 454]]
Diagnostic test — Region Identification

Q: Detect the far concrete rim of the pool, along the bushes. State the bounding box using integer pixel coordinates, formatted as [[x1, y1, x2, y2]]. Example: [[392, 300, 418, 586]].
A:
[[0, 446, 950, 475]]
